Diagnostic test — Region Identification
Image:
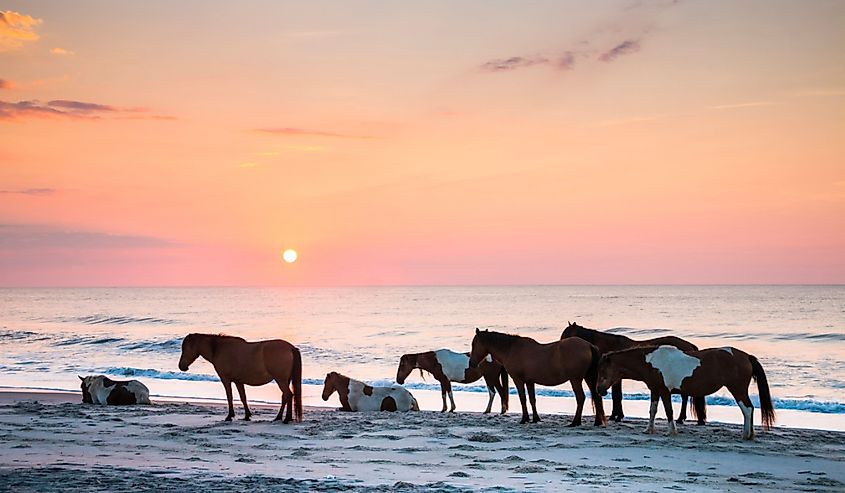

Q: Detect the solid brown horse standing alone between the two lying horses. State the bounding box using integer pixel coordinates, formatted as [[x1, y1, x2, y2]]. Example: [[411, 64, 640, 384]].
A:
[[179, 334, 302, 423]]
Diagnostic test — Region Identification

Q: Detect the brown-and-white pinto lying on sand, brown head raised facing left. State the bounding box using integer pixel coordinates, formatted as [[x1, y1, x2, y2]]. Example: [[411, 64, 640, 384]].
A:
[[323, 371, 420, 412]]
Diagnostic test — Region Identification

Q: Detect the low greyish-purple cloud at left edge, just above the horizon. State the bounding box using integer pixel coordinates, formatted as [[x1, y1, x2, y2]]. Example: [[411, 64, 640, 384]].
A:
[[0, 224, 181, 250]]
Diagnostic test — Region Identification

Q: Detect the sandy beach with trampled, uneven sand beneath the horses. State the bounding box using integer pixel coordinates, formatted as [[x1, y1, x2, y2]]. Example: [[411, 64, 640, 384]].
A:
[[0, 392, 845, 492]]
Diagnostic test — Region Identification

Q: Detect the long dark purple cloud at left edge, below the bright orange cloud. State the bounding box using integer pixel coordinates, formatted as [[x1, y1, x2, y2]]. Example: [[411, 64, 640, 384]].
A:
[[0, 99, 174, 121]]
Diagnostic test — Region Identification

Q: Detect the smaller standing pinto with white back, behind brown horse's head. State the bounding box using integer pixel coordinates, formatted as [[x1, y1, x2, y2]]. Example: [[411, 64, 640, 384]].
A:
[[396, 349, 508, 414]]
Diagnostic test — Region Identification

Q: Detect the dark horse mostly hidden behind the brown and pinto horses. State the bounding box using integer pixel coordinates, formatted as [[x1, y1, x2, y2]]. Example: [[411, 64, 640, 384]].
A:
[[560, 322, 706, 425]]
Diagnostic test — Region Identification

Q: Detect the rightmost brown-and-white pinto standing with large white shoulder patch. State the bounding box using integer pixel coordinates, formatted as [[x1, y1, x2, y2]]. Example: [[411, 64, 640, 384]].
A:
[[598, 346, 775, 440]]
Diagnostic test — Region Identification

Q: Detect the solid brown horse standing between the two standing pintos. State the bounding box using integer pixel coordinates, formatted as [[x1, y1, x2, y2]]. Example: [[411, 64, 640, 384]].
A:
[[469, 329, 606, 426]]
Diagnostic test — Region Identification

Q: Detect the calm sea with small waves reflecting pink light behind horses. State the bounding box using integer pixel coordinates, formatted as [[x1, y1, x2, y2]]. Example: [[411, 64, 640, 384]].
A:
[[0, 286, 845, 428]]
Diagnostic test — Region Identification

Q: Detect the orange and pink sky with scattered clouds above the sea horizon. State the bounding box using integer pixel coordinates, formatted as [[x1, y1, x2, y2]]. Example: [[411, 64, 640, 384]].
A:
[[0, 0, 845, 286]]
